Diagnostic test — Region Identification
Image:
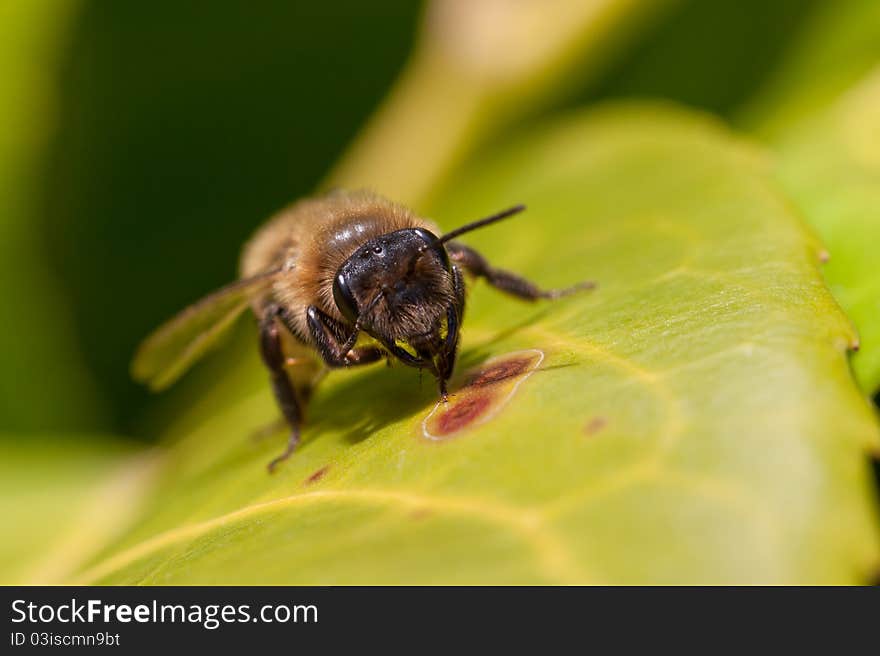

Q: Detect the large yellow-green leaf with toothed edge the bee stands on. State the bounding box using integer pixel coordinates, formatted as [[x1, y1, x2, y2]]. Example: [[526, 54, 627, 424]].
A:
[[69, 106, 880, 584]]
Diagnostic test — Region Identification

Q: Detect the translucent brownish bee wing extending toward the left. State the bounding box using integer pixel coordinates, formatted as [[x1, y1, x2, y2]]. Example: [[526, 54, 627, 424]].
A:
[[131, 269, 281, 391]]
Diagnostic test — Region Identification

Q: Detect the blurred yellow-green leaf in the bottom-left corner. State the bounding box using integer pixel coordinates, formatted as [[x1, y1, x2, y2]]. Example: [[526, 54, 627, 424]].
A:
[[0, 435, 159, 585]]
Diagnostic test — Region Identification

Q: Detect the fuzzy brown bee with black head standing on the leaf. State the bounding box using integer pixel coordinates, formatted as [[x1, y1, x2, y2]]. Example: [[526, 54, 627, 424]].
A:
[[131, 191, 592, 472]]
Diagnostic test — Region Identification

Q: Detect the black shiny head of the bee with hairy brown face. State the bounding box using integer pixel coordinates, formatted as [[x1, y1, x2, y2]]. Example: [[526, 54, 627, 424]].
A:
[[333, 228, 455, 358]]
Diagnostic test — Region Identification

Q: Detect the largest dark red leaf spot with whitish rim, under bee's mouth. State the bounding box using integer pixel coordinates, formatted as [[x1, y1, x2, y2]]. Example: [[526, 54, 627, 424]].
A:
[[422, 349, 544, 440]]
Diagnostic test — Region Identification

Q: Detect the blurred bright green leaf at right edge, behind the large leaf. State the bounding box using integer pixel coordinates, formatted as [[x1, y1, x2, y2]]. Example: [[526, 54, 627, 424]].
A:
[[743, 0, 880, 394]]
